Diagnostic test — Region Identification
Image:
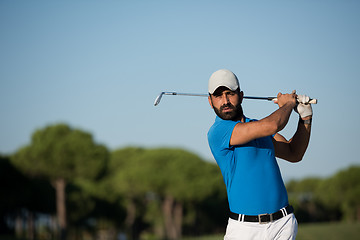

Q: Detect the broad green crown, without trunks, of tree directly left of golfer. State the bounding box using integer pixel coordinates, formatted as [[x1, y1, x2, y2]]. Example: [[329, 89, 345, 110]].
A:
[[104, 147, 221, 204]]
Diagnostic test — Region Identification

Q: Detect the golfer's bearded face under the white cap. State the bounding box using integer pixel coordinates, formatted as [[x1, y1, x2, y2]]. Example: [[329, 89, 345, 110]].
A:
[[209, 87, 243, 120]]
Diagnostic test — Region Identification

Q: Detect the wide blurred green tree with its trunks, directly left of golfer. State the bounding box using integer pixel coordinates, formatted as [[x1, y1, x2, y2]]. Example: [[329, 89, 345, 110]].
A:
[[100, 147, 222, 239]]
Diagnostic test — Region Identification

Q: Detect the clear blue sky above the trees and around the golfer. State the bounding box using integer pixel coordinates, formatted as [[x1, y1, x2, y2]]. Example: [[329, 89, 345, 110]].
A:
[[0, 0, 360, 182]]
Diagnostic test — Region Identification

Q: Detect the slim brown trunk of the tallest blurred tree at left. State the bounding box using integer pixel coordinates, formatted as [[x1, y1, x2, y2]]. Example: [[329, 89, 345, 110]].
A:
[[53, 178, 67, 240]]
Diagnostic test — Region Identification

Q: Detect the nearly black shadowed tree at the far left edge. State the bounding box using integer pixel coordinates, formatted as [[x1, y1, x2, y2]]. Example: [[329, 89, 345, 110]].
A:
[[0, 156, 55, 239]]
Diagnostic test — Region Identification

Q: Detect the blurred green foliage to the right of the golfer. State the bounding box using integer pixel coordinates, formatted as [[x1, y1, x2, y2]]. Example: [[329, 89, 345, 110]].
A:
[[287, 166, 360, 222]]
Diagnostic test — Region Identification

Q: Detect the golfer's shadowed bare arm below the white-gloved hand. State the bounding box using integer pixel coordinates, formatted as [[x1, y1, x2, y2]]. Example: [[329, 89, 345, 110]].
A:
[[273, 117, 311, 162]]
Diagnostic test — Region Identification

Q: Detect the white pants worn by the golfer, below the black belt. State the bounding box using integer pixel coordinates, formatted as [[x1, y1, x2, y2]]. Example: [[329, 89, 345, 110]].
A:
[[224, 213, 298, 240]]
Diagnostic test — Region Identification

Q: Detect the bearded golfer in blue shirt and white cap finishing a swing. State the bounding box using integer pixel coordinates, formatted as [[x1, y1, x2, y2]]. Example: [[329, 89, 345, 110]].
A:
[[208, 69, 312, 240]]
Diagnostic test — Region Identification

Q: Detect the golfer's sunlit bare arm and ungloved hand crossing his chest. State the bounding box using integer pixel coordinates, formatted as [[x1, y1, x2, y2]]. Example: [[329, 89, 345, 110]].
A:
[[230, 91, 296, 146]]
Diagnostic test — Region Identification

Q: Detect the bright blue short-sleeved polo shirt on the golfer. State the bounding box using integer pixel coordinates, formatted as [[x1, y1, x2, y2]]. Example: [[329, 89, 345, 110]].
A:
[[208, 117, 288, 215]]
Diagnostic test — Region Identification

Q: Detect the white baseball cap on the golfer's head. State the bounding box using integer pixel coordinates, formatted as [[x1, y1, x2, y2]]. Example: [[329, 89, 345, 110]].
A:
[[208, 69, 240, 94]]
